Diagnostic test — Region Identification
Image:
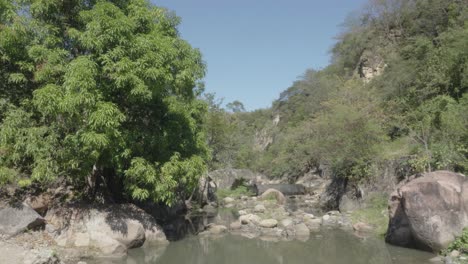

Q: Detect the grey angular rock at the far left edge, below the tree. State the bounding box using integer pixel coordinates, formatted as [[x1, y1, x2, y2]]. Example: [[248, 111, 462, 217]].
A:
[[0, 203, 45, 236]]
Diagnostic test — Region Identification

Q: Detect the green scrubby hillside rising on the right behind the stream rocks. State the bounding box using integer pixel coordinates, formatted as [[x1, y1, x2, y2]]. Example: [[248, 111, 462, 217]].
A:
[[207, 0, 468, 185]]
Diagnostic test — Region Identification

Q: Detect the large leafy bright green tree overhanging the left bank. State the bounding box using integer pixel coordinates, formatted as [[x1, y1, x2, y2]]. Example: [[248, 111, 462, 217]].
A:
[[0, 0, 208, 203]]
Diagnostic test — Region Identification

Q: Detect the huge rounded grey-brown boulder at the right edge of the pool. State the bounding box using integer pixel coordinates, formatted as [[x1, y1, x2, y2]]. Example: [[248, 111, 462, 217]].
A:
[[386, 171, 468, 252]]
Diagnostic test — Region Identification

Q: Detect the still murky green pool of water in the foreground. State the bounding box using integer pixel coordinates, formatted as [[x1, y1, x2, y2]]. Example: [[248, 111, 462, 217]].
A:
[[99, 230, 434, 264]]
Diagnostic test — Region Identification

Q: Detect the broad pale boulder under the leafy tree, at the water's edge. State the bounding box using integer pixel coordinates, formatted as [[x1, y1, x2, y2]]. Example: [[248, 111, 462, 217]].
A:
[[46, 204, 167, 256]]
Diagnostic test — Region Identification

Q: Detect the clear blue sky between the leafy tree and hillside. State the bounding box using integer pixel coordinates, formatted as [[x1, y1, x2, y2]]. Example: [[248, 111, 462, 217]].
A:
[[152, 0, 367, 110]]
